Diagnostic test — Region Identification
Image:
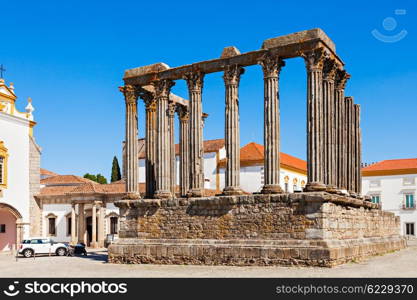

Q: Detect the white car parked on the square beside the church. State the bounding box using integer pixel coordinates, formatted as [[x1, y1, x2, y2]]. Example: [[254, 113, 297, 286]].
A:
[[19, 237, 68, 257]]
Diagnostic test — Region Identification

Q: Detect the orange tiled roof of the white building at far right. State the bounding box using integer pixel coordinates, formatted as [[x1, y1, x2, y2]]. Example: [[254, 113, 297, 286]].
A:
[[362, 158, 417, 176]]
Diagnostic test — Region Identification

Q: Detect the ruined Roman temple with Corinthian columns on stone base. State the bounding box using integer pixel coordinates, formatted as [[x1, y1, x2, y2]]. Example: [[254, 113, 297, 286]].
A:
[[109, 29, 405, 266]]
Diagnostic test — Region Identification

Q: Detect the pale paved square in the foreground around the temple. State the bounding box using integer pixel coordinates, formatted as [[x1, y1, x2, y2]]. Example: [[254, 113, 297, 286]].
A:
[[0, 244, 417, 278]]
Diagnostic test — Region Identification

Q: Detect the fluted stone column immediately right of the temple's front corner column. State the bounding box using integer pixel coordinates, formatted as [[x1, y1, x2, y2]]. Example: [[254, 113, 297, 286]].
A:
[[323, 58, 337, 193]]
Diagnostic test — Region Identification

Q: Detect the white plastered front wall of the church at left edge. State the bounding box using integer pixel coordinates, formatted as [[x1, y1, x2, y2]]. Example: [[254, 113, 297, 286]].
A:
[[0, 112, 29, 227]]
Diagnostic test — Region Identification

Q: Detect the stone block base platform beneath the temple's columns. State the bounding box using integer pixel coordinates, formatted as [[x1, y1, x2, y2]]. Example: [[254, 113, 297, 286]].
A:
[[109, 192, 406, 267]]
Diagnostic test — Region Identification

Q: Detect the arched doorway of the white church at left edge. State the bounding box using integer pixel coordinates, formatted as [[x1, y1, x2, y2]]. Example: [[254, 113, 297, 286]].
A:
[[0, 203, 22, 251]]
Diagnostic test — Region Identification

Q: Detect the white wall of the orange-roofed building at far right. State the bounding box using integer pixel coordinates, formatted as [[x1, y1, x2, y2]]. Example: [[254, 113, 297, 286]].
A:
[[362, 174, 417, 235]]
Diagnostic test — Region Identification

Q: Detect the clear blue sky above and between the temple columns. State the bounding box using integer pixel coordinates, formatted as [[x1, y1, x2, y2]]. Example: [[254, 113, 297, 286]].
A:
[[0, 0, 417, 177]]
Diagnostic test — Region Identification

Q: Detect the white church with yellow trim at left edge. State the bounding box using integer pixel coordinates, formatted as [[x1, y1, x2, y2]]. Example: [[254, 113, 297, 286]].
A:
[[0, 78, 40, 251]]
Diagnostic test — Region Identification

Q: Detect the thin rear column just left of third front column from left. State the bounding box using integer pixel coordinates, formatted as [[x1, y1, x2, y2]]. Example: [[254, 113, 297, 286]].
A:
[[177, 105, 190, 197]]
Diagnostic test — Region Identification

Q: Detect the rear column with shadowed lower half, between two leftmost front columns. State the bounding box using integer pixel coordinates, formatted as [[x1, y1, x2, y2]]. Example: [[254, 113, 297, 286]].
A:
[[139, 89, 156, 198]]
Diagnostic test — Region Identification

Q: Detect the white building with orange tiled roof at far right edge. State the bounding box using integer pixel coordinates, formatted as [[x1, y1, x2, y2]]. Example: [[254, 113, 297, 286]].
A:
[[362, 158, 417, 237]]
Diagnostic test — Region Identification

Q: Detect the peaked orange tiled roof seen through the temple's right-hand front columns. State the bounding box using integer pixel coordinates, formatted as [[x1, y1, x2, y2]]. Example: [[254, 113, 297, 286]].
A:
[[219, 142, 307, 173]]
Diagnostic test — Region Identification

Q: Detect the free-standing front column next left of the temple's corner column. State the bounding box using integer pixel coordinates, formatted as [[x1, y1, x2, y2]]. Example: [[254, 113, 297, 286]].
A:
[[259, 53, 285, 194]]
